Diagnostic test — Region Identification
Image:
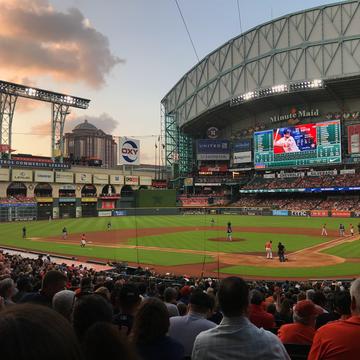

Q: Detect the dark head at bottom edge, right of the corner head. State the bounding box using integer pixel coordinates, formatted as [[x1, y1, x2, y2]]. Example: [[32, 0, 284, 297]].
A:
[[82, 322, 137, 360]]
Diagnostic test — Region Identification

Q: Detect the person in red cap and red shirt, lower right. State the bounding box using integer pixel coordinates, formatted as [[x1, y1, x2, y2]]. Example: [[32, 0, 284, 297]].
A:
[[278, 300, 317, 345]]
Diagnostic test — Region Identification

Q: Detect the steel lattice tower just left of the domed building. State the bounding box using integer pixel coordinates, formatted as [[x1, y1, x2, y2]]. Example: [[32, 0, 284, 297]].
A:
[[51, 103, 70, 162]]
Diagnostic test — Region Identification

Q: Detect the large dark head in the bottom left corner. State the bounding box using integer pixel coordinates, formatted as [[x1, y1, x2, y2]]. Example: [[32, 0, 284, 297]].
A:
[[0, 304, 83, 360]]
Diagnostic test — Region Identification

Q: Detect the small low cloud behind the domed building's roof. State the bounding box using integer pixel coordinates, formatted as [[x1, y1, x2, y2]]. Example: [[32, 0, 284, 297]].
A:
[[31, 113, 117, 136]]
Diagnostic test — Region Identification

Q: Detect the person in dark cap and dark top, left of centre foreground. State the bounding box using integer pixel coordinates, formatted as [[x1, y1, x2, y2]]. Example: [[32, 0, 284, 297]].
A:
[[113, 284, 141, 335]]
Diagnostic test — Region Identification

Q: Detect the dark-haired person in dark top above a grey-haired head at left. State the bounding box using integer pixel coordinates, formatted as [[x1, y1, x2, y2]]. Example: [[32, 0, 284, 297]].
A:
[[20, 270, 66, 307]]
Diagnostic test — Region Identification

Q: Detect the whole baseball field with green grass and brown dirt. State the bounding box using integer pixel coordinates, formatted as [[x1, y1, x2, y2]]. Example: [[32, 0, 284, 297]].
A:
[[0, 215, 360, 279]]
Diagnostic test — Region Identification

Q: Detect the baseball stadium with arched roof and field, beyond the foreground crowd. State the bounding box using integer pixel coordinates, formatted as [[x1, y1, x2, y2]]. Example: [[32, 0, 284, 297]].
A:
[[0, 1, 360, 280]]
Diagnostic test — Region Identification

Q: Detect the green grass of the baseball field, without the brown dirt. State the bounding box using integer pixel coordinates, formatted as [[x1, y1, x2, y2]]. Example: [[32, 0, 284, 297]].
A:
[[0, 215, 360, 277]]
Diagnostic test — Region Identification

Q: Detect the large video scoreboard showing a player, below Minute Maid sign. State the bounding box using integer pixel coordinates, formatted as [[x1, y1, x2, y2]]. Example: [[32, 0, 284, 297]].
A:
[[254, 120, 341, 169]]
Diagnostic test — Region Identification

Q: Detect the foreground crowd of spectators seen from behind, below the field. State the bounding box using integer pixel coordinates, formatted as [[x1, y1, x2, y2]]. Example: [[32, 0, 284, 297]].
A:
[[0, 252, 360, 360]]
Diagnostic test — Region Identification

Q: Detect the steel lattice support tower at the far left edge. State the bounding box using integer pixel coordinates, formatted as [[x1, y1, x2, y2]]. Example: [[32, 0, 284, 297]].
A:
[[0, 93, 18, 159]]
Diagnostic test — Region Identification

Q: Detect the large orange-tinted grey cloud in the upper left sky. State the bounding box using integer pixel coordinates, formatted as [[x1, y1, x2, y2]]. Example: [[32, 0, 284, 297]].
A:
[[0, 0, 124, 88]]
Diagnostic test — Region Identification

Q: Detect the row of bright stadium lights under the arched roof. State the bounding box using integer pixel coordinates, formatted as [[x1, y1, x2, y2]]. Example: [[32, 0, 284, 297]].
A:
[[230, 79, 324, 106]]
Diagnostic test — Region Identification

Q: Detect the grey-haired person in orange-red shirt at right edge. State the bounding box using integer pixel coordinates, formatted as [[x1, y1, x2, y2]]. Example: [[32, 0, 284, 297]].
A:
[[308, 278, 360, 360]]
